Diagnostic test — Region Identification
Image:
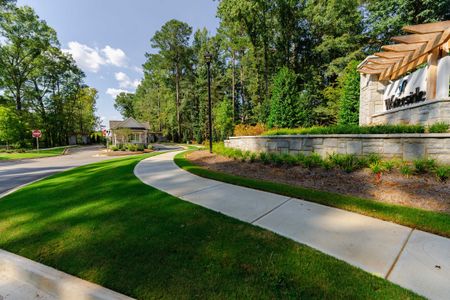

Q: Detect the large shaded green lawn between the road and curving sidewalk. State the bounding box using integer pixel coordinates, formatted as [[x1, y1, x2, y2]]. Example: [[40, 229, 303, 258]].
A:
[[0, 155, 418, 299]]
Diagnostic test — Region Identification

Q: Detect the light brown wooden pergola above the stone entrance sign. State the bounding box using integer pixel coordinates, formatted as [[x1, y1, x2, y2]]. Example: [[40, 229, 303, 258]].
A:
[[358, 21, 450, 99]]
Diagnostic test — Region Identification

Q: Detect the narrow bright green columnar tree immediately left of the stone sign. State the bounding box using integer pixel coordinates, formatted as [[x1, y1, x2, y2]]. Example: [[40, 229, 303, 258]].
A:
[[338, 61, 360, 125]]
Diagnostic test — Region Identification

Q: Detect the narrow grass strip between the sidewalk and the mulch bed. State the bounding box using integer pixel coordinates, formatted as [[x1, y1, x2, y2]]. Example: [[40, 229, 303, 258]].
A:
[[175, 153, 450, 237]]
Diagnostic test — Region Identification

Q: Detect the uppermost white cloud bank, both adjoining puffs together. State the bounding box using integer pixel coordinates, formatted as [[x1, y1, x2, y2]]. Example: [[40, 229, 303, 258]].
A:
[[63, 41, 128, 73]]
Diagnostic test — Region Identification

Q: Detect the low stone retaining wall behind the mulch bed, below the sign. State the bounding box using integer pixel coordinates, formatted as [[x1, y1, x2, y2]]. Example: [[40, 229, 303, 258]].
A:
[[225, 133, 450, 164]]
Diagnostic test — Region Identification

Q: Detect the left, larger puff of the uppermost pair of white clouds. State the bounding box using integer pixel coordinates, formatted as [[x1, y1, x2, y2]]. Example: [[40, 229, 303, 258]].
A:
[[63, 42, 106, 73]]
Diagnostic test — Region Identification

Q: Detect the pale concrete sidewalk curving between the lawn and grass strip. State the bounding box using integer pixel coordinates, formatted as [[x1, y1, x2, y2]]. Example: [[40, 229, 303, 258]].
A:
[[134, 152, 450, 299]]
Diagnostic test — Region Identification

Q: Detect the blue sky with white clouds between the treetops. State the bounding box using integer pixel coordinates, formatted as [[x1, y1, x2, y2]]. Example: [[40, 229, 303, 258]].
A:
[[17, 0, 219, 125]]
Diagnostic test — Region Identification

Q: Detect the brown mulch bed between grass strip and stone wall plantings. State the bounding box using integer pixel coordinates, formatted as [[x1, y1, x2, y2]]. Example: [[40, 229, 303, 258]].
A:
[[187, 151, 450, 213]]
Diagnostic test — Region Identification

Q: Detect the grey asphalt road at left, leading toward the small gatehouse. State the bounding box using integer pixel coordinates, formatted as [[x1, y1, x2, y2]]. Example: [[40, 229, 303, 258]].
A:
[[0, 146, 112, 197]]
